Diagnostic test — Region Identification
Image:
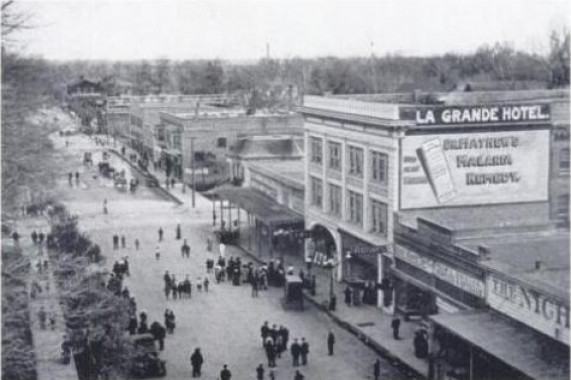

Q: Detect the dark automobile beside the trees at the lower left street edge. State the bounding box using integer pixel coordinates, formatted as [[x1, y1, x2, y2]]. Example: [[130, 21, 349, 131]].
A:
[[131, 334, 167, 379]]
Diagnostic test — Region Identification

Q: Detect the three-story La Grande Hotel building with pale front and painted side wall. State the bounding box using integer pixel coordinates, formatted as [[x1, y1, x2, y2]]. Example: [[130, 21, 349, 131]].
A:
[[299, 92, 569, 305]]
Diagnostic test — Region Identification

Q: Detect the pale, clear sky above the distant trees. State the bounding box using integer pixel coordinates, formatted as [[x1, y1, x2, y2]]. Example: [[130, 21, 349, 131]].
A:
[[10, 0, 571, 60]]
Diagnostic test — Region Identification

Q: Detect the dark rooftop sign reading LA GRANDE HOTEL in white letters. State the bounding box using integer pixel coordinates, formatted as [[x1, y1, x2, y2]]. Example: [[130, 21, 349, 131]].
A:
[[400, 104, 551, 125]]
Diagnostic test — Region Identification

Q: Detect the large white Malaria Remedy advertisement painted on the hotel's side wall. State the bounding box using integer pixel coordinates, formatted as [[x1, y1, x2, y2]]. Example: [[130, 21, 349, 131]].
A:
[[401, 130, 549, 209]]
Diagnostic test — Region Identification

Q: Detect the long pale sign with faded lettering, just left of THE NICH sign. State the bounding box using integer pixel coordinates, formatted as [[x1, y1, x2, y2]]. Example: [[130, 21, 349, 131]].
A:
[[395, 245, 486, 298]]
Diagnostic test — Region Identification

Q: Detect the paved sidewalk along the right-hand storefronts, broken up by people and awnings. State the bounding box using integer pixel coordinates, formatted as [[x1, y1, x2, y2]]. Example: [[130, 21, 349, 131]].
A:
[[110, 137, 428, 378]]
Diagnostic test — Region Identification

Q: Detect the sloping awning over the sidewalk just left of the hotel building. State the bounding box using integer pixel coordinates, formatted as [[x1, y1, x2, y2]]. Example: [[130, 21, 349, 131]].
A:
[[209, 186, 304, 228]]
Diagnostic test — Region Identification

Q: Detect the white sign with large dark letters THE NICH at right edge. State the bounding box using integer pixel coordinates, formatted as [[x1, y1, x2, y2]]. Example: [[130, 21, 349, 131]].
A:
[[487, 275, 569, 344]]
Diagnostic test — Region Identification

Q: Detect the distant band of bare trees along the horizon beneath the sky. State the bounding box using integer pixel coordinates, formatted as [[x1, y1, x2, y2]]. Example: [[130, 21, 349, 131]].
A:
[[53, 32, 569, 95]]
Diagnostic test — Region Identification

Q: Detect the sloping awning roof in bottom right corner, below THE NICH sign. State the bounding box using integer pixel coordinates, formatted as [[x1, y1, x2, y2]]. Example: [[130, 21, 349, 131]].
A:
[[430, 311, 569, 380]]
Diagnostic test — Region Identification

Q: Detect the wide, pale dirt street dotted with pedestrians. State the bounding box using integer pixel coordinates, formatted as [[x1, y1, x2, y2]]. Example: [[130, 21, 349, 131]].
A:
[[54, 131, 405, 380]]
